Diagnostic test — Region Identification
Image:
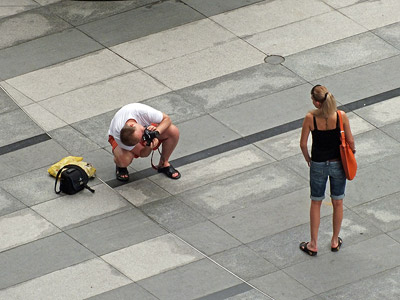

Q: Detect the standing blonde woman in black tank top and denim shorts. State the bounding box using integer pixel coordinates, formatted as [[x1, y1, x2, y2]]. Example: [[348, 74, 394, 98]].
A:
[[300, 85, 356, 256]]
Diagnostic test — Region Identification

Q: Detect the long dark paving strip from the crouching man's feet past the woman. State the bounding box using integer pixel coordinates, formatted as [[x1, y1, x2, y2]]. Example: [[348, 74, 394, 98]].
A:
[[106, 88, 400, 188]]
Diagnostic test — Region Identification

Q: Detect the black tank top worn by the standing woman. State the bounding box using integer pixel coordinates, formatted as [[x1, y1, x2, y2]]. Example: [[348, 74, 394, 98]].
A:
[[311, 113, 340, 162]]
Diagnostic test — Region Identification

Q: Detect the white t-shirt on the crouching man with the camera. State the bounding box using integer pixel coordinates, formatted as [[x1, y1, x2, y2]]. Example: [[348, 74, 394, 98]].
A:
[[108, 103, 163, 151]]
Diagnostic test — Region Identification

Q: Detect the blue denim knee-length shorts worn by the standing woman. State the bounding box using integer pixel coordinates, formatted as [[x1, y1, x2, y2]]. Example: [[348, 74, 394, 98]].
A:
[[310, 160, 346, 201]]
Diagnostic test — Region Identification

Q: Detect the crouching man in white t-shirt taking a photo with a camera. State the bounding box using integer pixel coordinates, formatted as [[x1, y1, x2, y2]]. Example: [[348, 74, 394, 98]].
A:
[[108, 103, 181, 181]]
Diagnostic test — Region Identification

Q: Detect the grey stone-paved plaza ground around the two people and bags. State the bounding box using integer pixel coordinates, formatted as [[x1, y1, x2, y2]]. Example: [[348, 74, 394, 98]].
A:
[[0, 0, 400, 300]]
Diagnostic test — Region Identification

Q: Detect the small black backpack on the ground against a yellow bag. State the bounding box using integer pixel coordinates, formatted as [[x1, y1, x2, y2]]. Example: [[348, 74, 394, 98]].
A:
[[54, 165, 94, 195]]
